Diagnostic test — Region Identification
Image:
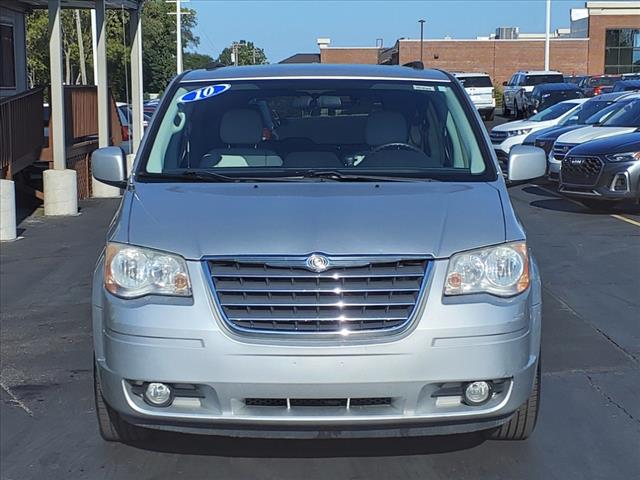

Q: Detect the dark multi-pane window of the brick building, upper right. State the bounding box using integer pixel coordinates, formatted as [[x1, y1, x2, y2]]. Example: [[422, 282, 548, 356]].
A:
[[604, 28, 640, 74]]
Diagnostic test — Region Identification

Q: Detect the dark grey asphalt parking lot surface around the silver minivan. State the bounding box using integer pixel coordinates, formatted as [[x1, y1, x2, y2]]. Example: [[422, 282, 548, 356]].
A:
[[0, 113, 640, 480]]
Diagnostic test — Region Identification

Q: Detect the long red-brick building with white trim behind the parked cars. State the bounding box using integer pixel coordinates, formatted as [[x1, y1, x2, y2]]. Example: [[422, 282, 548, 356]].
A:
[[312, 1, 640, 83]]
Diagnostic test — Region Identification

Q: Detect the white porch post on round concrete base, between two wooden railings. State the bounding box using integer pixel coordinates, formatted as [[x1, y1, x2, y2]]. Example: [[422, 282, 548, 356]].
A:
[[43, 0, 78, 215]]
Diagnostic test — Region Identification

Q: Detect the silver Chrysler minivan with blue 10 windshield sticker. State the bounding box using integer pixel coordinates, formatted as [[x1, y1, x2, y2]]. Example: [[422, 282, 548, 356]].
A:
[[92, 65, 546, 442]]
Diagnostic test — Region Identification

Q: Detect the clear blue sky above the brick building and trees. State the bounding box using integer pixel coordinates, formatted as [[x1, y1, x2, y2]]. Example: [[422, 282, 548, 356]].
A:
[[185, 0, 585, 63]]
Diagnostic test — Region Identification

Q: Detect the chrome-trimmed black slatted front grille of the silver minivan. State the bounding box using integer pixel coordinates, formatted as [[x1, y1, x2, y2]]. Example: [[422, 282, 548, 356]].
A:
[[207, 257, 428, 335]]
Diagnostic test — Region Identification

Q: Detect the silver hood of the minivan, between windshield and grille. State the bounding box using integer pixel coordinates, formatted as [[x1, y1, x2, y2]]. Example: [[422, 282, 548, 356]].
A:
[[124, 182, 504, 260]]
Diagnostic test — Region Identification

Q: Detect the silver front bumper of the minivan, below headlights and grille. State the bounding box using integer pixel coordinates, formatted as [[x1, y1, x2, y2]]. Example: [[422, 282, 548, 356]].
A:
[[93, 261, 541, 437]]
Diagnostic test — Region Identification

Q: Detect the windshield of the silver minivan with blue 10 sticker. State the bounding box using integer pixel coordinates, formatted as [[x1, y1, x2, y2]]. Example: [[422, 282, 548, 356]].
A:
[[138, 79, 495, 181]]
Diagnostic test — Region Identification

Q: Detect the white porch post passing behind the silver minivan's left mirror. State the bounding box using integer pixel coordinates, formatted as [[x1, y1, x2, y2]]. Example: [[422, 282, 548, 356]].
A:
[[91, 0, 120, 198]]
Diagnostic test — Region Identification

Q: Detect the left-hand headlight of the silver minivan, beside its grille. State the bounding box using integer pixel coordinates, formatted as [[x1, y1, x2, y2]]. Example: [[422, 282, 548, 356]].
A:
[[104, 243, 191, 298]]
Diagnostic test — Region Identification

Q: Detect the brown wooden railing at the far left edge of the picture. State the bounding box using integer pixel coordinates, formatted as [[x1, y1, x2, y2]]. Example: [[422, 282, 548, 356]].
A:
[[0, 88, 44, 178]]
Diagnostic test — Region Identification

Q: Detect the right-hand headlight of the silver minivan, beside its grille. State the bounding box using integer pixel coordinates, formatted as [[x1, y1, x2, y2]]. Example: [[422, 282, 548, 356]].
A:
[[444, 242, 529, 297]]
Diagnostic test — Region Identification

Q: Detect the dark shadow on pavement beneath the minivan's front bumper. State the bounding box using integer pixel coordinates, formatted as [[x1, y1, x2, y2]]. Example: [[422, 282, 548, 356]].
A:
[[130, 432, 485, 458]]
